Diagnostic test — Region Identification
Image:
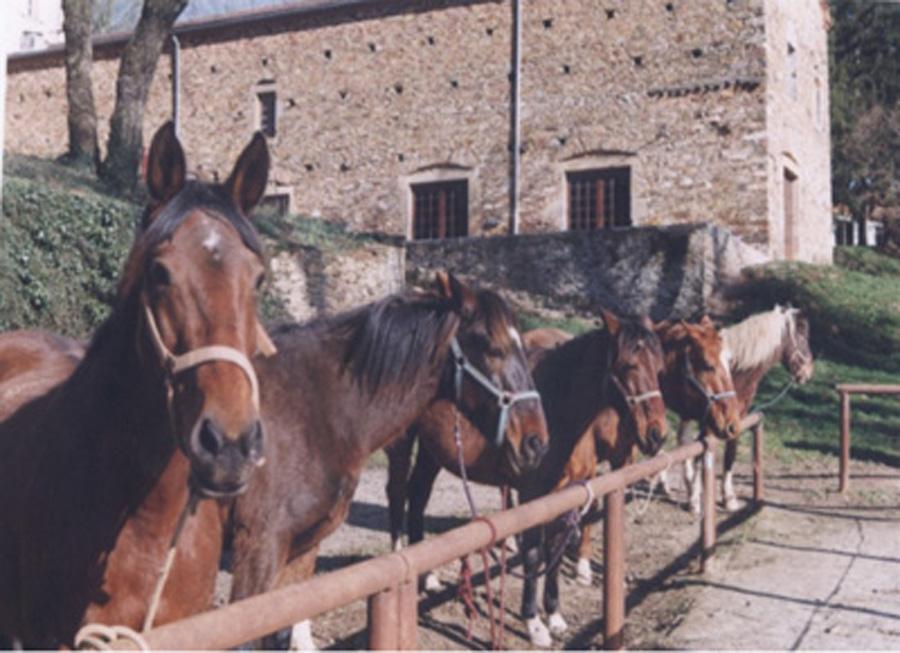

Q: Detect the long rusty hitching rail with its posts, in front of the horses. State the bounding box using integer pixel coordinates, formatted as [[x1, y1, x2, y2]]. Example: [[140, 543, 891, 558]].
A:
[[113, 414, 762, 649]]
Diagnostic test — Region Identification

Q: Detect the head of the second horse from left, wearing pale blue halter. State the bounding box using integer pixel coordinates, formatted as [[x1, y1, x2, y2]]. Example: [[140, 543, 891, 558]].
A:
[[436, 273, 550, 476]]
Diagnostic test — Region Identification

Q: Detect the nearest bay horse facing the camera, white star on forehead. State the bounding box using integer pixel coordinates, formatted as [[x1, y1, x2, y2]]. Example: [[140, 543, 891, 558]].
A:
[[0, 123, 268, 648]]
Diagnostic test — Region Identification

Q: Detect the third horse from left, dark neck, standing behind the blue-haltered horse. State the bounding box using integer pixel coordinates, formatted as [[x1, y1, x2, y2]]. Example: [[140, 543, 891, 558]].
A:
[[388, 313, 666, 647]]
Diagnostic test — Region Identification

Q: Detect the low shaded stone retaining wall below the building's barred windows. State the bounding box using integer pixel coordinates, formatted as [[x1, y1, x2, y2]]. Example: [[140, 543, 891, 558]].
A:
[[406, 224, 765, 320]]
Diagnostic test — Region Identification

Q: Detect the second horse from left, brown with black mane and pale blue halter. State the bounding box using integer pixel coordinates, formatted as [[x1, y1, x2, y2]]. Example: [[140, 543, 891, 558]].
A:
[[232, 274, 548, 648]]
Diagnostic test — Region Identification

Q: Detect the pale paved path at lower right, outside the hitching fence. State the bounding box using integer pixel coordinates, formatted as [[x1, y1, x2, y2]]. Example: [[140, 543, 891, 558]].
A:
[[667, 460, 900, 649]]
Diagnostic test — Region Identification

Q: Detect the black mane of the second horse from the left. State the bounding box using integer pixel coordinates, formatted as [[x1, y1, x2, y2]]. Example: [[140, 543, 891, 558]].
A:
[[273, 291, 459, 396]]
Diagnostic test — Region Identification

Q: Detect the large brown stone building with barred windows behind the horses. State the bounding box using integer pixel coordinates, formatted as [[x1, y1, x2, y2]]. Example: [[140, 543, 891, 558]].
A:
[[6, 0, 833, 262]]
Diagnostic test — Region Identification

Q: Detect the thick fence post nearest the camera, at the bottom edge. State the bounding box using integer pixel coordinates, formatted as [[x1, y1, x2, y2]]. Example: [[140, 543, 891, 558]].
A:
[[368, 583, 419, 651]]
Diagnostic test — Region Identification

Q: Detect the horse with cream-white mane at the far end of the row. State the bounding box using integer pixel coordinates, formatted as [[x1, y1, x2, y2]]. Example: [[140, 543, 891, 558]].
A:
[[678, 306, 814, 512]]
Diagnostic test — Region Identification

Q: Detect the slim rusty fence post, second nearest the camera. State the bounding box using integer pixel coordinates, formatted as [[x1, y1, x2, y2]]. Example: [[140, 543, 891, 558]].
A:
[[603, 488, 625, 651]]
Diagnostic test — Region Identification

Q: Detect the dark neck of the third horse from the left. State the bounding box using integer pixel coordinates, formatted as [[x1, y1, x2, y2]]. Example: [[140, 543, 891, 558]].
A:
[[533, 331, 611, 459]]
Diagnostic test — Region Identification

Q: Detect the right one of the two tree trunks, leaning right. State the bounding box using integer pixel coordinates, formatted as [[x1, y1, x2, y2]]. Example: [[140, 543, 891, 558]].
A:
[[100, 0, 188, 194]]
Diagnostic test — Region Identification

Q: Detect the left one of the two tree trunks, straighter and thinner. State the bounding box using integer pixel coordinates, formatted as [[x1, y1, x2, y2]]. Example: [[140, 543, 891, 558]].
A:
[[63, 0, 98, 168]]
